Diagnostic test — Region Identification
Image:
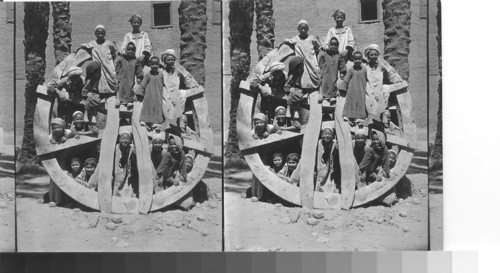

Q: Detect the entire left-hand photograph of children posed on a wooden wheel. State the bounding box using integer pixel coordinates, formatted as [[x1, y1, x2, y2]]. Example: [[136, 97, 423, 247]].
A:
[[15, 0, 222, 252]]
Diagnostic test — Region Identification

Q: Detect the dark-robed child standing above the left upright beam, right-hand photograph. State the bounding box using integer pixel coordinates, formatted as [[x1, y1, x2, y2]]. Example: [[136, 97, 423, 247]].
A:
[[318, 37, 347, 102]]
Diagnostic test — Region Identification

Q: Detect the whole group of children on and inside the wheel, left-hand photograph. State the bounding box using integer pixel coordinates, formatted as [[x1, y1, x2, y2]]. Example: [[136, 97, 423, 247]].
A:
[[47, 14, 199, 204]]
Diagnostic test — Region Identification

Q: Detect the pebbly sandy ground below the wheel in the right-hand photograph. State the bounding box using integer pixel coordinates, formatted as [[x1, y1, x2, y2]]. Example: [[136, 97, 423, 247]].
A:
[[224, 146, 429, 251]]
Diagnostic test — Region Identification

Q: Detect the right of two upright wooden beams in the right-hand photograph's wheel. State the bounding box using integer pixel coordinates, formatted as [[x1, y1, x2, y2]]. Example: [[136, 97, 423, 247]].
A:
[[335, 97, 356, 210]]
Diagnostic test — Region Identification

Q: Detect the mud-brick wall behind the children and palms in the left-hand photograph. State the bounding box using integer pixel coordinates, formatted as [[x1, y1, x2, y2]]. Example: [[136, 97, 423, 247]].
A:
[[15, 0, 222, 144]]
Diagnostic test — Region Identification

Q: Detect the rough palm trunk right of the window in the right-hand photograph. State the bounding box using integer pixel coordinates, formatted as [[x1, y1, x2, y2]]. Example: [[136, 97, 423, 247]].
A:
[[382, 0, 411, 81]]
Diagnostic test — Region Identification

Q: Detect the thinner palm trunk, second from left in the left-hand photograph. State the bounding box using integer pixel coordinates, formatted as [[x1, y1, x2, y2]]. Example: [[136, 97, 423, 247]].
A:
[[52, 2, 72, 65]]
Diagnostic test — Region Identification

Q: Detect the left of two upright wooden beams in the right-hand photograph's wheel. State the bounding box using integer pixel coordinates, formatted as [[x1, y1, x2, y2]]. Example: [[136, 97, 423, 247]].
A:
[[300, 91, 322, 208]]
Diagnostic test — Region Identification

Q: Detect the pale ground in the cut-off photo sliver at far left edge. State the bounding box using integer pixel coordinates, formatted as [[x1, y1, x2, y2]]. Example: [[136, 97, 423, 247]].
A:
[[0, 131, 16, 252]]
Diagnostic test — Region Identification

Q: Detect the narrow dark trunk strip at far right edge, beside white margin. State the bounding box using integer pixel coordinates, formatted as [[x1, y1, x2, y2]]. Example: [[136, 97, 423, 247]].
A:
[[429, 0, 443, 169]]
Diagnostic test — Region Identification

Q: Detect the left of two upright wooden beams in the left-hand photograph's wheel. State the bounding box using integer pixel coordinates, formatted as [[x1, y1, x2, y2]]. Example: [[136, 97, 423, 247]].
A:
[[97, 97, 120, 213]]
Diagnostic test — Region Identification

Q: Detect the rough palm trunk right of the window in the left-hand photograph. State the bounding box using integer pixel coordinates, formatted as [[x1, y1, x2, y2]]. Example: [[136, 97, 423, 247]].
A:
[[178, 0, 207, 85]]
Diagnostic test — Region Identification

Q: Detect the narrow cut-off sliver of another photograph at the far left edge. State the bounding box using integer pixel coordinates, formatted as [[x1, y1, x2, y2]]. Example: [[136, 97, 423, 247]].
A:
[[0, 3, 16, 252]]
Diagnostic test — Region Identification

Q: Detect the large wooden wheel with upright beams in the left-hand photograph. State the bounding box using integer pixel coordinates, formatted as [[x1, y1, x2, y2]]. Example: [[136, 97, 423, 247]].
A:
[[34, 50, 213, 214]]
